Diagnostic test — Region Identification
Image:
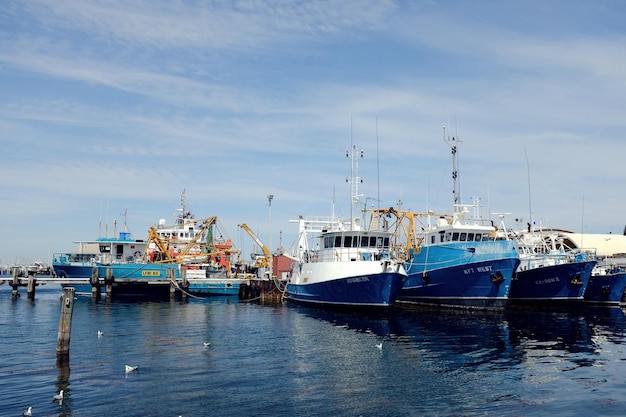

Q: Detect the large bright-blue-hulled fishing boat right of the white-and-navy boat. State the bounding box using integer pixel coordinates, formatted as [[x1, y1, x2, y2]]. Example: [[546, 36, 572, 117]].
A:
[[372, 138, 520, 310]]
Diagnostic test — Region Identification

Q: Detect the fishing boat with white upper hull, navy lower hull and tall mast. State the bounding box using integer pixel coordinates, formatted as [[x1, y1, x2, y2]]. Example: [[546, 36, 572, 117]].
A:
[[285, 146, 407, 310]]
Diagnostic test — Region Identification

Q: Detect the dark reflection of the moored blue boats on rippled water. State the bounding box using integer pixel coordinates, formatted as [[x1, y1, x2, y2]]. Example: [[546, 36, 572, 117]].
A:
[[300, 307, 626, 370]]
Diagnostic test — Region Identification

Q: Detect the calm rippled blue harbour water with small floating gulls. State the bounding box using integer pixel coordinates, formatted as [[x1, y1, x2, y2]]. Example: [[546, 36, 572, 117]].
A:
[[0, 285, 626, 417]]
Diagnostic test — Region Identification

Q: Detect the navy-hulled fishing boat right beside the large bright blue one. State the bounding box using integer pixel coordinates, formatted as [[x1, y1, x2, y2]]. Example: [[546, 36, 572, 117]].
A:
[[508, 229, 597, 309]]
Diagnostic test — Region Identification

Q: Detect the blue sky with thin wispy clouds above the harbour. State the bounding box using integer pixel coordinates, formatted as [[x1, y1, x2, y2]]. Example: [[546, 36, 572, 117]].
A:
[[0, 0, 626, 264]]
